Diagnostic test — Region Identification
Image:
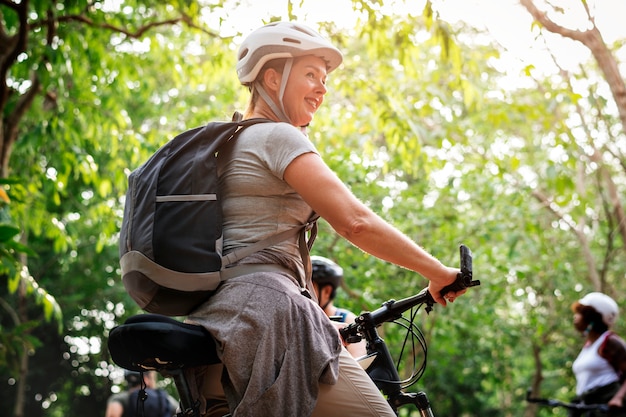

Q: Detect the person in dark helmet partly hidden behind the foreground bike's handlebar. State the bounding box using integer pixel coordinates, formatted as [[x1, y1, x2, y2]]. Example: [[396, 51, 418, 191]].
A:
[[311, 255, 367, 358]]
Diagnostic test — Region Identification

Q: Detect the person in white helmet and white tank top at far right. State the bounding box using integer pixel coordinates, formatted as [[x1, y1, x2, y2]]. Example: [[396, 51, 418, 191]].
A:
[[572, 292, 626, 416]]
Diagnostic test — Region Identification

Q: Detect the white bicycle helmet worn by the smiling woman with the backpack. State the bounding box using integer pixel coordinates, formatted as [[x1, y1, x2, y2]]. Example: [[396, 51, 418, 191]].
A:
[[237, 22, 343, 85]]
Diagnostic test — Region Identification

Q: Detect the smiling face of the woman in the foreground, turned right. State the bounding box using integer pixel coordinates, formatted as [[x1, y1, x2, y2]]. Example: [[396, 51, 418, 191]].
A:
[[283, 55, 326, 126]]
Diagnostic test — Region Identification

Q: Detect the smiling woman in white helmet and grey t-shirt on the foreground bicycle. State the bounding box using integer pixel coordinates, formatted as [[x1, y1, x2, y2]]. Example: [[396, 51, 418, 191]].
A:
[[189, 22, 464, 417]]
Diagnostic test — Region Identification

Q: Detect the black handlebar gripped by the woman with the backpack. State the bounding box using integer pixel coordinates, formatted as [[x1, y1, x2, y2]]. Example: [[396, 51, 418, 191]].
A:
[[339, 245, 480, 343]]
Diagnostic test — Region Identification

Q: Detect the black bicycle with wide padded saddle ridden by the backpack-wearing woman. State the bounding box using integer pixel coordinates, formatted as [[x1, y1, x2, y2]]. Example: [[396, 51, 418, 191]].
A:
[[108, 245, 480, 417]]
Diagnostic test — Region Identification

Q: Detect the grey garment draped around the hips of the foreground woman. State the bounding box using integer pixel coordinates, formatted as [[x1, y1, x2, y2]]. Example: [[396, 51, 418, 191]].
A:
[[187, 272, 342, 417]]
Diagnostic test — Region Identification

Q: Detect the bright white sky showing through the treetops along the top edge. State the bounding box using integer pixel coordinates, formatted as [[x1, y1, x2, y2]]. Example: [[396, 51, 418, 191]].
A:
[[213, 0, 626, 76]]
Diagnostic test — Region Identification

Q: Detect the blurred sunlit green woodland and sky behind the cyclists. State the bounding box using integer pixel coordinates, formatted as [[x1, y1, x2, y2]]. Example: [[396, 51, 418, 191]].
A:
[[0, 0, 626, 417]]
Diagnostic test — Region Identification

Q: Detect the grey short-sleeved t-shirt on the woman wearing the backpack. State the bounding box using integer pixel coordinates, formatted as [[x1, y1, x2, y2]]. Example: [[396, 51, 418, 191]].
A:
[[218, 123, 317, 277]]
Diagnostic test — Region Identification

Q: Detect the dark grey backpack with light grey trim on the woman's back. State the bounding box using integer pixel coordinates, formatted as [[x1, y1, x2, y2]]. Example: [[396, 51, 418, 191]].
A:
[[120, 113, 316, 316]]
